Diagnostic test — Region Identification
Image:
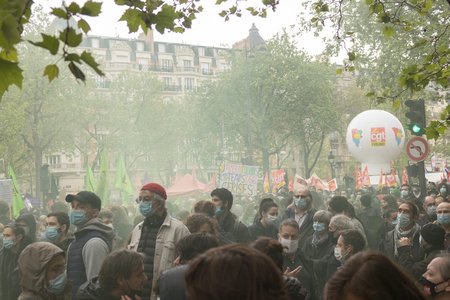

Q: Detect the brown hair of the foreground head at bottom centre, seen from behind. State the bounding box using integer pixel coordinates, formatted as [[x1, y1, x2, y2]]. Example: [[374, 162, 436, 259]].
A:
[[185, 244, 287, 300]]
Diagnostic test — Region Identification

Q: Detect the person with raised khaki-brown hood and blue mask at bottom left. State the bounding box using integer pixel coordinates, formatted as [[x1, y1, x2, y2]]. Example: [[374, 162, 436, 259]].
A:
[[18, 242, 71, 300]]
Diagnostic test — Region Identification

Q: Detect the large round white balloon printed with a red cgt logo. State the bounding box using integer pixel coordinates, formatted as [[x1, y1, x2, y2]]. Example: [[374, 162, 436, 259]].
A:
[[346, 109, 405, 175]]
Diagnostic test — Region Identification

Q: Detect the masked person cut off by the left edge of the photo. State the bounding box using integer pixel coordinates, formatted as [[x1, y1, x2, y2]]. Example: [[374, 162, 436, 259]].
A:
[[0, 224, 31, 300]]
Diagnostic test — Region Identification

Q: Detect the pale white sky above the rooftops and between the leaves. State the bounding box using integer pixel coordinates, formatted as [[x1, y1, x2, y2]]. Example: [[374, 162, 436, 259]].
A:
[[35, 0, 324, 54]]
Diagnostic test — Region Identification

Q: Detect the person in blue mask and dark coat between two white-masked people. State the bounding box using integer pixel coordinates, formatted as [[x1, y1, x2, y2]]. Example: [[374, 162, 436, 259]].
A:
[[302, 210, 335, 299]]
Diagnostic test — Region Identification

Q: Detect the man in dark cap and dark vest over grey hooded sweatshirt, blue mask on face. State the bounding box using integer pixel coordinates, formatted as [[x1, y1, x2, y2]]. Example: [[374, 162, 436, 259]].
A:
[[66, 191, 113, 298]]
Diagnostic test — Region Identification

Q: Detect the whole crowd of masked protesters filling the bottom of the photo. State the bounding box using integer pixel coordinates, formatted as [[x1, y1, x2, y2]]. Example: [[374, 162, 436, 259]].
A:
[[0, 177, 450, 300]]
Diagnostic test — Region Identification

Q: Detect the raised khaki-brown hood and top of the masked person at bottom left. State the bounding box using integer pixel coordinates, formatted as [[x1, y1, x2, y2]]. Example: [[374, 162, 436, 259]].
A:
[[19, 242, 70, 300]]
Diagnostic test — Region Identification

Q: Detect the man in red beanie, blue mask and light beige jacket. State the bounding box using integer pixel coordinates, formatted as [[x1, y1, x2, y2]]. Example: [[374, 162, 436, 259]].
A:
[[128, 183, 189, 300]]
